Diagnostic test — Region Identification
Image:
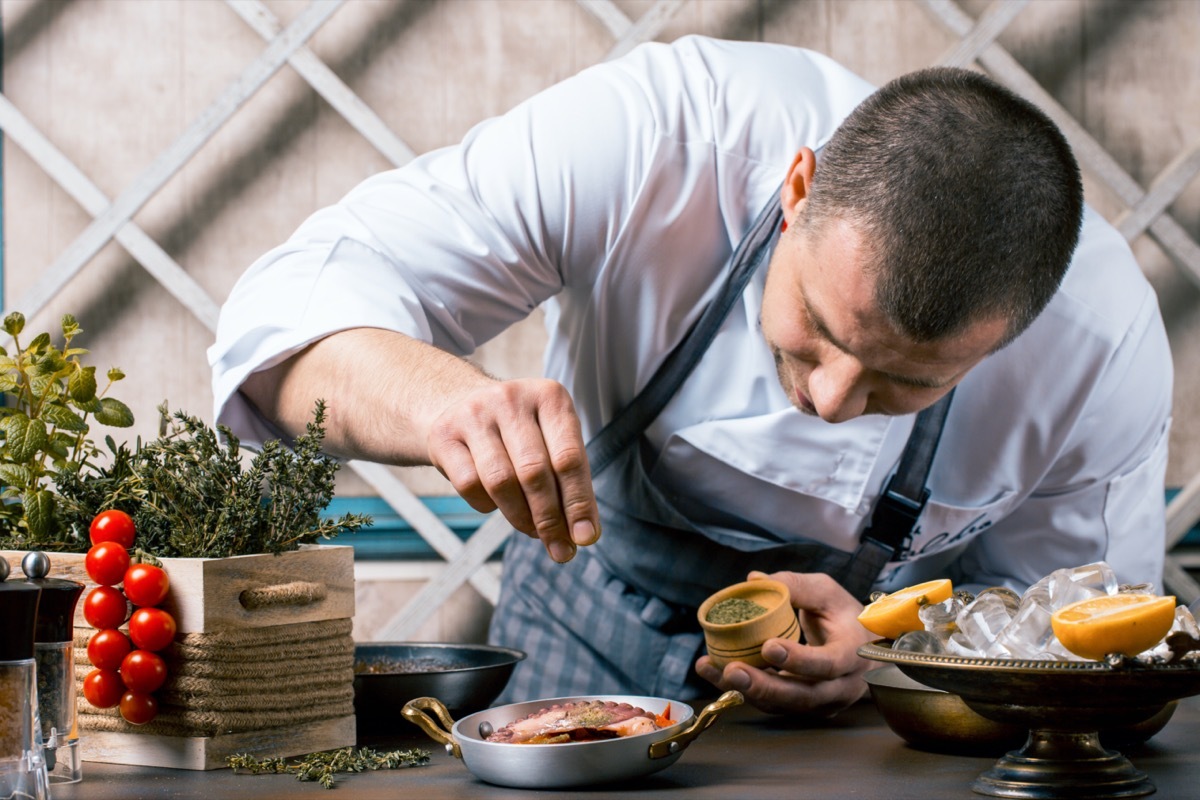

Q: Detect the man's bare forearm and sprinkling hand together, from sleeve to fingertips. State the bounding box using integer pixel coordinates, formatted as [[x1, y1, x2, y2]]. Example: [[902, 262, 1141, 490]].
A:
[[242, 327, 600, 561]]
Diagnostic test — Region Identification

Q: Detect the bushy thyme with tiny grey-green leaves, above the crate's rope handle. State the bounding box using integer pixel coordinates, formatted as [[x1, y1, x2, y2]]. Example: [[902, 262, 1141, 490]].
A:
[[60, 401, 371, 558]]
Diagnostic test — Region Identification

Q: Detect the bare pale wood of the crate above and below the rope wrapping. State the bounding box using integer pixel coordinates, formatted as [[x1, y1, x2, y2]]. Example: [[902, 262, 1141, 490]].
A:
[[0, 545, 355, 770]]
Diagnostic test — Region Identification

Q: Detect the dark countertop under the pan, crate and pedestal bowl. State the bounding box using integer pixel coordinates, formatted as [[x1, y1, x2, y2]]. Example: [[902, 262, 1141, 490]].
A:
[[53, 698, 1200, 800]]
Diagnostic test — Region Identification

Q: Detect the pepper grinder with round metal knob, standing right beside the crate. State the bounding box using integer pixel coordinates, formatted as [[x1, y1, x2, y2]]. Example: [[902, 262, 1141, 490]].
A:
[[20, 552, 84, 786]]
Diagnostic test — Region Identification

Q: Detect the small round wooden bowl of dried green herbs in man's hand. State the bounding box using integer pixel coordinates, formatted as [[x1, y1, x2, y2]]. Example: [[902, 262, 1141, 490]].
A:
[[696, 578, 800, 669]]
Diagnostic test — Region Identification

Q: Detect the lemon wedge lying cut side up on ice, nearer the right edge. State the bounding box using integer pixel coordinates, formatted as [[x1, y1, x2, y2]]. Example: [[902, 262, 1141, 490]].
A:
[[1050, 594, 1175, 661]]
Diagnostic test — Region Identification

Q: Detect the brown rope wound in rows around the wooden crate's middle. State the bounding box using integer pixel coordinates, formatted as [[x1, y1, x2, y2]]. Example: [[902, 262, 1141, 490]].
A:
[[74, 619, 354, 736]]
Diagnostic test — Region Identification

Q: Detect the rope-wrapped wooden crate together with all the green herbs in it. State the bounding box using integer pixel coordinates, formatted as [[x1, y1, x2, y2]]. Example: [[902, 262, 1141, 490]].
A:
[[0, 314, 370, 769]]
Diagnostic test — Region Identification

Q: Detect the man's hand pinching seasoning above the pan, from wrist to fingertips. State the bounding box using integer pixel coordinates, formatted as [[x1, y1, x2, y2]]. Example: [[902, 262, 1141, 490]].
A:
[[428, 379, 600, 563]]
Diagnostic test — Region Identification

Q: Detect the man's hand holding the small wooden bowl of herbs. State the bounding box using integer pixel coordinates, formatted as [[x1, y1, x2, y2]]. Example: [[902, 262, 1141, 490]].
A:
[[696, 572, 875, 716]]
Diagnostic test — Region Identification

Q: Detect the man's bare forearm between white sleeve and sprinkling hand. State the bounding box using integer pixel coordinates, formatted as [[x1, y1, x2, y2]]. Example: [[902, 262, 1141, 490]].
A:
[[241, 329, 492, 465]]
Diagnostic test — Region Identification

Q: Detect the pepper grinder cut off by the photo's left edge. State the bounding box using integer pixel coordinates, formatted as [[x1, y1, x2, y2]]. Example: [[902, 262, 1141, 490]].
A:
[[0, 573, 50, 800]]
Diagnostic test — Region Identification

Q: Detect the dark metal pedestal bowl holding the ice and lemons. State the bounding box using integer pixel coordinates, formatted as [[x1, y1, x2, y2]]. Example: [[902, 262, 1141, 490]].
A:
[[858, 642, 1200, 800]]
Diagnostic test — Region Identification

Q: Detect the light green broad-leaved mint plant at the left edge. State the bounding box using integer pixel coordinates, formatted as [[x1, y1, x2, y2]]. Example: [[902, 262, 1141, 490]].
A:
[[0, 312, 133, 551]]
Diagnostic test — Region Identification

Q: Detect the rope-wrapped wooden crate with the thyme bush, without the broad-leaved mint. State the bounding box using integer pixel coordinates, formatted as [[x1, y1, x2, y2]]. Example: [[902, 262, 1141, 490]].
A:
[[29, 402, 371, 769]]
